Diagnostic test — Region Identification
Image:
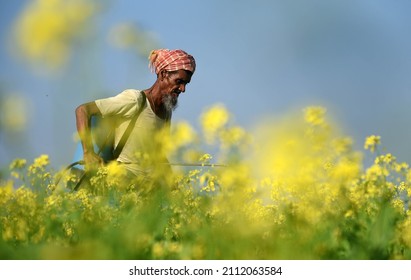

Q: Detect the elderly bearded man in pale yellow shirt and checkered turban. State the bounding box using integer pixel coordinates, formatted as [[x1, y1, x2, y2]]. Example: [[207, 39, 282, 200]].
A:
[[76, 49, 196, 186]]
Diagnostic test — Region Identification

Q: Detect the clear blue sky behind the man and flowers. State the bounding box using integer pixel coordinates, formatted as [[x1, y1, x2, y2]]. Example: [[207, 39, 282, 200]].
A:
[[0, 0, 411, 167]]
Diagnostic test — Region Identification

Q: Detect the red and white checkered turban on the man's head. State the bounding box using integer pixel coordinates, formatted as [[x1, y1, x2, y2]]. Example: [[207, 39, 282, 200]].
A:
[[148, 49, 196, 74]]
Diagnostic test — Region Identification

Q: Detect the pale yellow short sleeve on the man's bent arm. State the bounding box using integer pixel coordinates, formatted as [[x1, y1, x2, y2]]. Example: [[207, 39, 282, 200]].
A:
[[95, 89, 144, 118]]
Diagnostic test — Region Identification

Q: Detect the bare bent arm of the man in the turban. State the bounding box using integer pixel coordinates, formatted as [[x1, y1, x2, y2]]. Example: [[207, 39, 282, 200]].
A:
[[76, 101, 103, 168]]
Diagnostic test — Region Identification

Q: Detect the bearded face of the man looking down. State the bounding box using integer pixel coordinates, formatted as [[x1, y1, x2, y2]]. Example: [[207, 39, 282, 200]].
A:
[[162, 70, 192, 111]]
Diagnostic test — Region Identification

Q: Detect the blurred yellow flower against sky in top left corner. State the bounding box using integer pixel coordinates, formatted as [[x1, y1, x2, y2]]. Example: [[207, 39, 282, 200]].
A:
[[13, 0, 97, 68]]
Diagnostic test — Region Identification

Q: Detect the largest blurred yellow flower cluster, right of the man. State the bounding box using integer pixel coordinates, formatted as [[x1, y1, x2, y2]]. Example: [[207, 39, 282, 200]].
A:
[[250, 107, 362, 223]]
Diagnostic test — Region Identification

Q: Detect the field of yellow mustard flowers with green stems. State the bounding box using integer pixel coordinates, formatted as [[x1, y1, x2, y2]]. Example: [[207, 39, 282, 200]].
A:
[[0, 105, 411, 260]]
